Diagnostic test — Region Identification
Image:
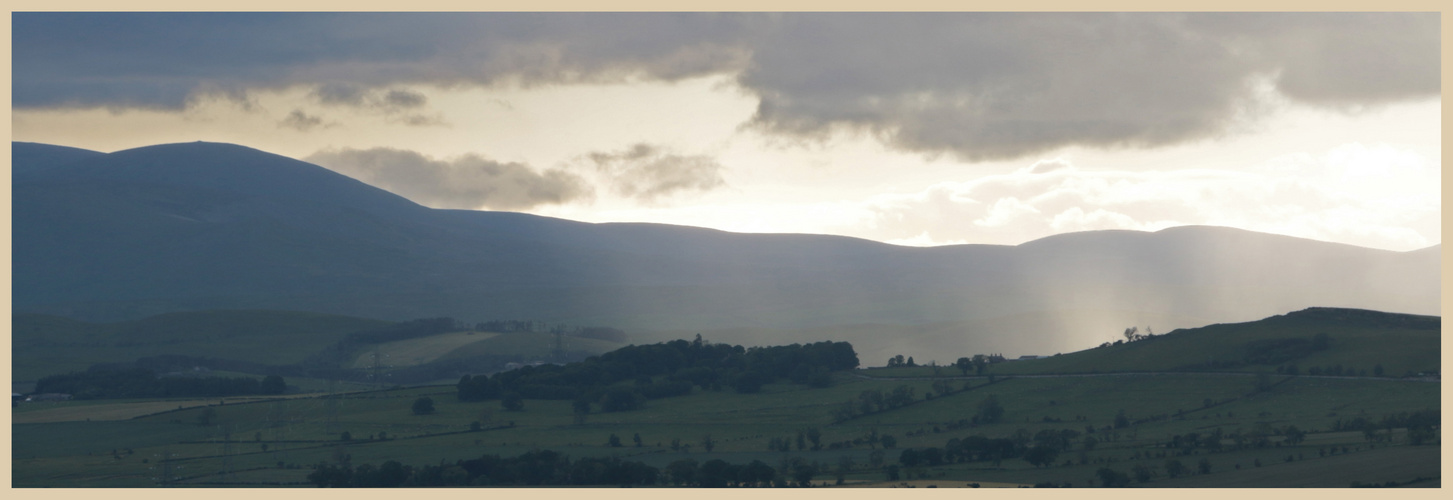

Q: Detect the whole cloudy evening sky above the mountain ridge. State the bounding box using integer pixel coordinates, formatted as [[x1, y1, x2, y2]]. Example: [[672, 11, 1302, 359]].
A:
[[12, 13, 1441, 251]]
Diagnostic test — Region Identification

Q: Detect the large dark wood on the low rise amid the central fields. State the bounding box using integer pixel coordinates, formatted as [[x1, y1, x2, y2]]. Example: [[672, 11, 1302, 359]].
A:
[[456, 336, 857, 411]]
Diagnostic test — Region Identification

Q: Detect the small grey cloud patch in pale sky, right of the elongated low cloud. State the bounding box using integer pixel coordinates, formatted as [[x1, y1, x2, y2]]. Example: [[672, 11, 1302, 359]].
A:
[[586, 144, 727, 202]]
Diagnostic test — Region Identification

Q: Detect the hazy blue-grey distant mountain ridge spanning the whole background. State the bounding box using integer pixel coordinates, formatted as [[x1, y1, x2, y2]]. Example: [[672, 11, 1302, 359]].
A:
[[12, 142, 1441, 359]]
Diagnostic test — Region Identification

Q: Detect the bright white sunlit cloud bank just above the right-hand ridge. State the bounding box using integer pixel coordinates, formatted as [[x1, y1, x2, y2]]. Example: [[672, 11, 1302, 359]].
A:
[[843, 142, 1441, 250]]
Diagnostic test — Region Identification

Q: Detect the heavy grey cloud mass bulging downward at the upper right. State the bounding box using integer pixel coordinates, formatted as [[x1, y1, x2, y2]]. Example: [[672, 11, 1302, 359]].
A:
[[741, 13, 1440, 160]]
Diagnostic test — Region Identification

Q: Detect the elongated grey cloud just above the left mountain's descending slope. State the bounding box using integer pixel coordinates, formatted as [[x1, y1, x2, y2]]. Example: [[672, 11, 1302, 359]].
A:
[[305, 148, 593, 209]]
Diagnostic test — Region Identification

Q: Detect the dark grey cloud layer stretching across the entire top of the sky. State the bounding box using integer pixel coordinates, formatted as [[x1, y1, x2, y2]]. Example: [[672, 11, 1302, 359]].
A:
[[13, 13, 1440, 160]]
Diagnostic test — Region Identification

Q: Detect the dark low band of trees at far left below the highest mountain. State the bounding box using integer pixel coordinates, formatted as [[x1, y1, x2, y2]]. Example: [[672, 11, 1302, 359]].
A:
[[35, 368, 288, 400]]
